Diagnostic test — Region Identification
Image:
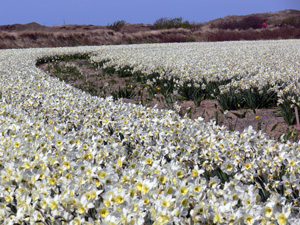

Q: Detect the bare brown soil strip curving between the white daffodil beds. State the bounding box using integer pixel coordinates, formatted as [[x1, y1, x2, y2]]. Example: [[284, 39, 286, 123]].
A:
[[39, 60, 300, 141]]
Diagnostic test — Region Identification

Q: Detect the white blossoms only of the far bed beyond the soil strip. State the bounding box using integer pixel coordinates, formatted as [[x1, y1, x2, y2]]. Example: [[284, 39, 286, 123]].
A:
[[92, 40, 300, 105]]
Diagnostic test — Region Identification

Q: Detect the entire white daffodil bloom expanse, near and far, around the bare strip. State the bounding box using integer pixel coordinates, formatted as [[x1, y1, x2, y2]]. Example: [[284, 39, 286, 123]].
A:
[[0, 40, 300, 225]]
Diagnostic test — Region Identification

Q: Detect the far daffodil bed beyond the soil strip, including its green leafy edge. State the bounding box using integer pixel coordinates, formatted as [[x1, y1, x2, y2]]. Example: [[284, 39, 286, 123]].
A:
[[92, 40, 300, 124]]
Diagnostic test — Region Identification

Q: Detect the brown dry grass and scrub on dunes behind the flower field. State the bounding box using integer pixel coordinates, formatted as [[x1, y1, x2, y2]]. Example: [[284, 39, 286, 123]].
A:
[[0, 10, 300, 49]]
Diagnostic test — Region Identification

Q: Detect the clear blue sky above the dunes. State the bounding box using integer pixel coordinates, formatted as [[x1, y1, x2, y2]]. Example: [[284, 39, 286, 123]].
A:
[[0, 0, 300, 26]]
